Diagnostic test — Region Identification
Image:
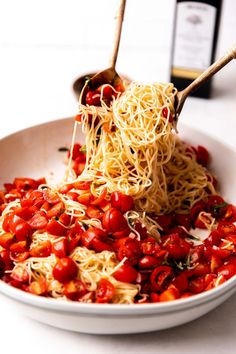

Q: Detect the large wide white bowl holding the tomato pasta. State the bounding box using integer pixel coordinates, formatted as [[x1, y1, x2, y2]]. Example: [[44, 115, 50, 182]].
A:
[[0, 118, 236, 334]]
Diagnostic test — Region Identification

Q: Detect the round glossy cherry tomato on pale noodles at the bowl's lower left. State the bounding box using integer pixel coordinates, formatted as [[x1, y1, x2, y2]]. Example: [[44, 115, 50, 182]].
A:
[[52, 257, 78, 283]]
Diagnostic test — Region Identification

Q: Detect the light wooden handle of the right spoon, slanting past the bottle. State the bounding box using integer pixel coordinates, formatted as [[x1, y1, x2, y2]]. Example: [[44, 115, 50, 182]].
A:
[[182, 46, 236, 97]]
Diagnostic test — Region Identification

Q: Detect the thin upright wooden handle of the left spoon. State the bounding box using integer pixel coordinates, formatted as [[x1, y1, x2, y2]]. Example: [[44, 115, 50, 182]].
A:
[[110, 0, 126, 69]]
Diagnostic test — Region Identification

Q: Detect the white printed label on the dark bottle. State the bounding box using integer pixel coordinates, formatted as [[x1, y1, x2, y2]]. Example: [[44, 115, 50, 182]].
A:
[[172, 1, 216, 78]]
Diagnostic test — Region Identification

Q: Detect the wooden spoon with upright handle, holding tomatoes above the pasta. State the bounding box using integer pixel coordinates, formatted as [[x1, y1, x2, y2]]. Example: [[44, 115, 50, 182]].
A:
[[73, 0, 126, 103]]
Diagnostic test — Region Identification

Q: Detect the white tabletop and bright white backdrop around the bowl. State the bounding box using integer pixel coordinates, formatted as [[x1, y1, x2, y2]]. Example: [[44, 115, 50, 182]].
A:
[[0, 0, 236, 354]]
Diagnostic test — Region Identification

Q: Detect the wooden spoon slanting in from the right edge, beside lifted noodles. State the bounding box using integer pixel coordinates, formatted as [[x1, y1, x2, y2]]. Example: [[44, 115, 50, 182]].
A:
[[175, 46, 236, 123]]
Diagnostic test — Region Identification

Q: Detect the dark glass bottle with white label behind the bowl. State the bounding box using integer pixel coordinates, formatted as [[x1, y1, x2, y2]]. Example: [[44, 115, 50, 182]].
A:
[[171, 0, 222, 98]]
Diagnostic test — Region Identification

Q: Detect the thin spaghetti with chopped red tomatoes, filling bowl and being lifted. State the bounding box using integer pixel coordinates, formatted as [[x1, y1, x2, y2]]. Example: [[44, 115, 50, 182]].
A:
[[0, 82, 236, 304]]
